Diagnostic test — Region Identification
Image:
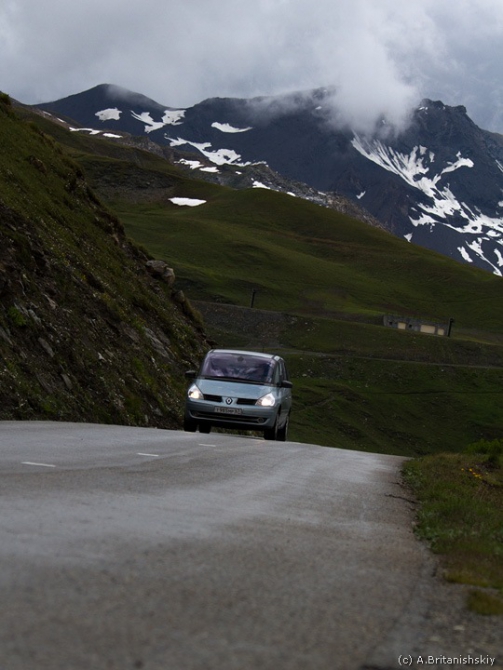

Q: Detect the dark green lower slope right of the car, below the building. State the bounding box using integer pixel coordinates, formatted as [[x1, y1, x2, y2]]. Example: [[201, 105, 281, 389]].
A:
[[288, 356, 503, 456]]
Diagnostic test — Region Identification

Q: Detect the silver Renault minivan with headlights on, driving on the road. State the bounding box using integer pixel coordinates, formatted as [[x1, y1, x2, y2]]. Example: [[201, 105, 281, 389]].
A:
[[183, 349, 292, 441]]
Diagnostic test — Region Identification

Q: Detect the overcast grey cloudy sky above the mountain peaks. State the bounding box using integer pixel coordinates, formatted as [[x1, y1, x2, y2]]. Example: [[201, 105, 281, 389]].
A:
[[0, 0, 503, 132]]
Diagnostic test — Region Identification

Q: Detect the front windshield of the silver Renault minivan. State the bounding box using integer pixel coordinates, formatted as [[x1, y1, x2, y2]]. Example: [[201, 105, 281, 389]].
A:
[[201, 351, 274, 383]]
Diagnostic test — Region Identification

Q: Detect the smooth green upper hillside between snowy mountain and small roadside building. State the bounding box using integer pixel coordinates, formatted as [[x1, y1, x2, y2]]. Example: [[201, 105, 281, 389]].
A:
[[117, 183, 503, 331]]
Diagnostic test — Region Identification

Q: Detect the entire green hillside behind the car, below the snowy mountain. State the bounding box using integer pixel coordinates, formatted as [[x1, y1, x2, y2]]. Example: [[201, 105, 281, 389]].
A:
[[19, 105, 503, 455]]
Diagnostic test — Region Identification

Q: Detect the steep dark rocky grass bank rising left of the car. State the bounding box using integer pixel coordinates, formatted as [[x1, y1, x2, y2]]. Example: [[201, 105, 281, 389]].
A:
[[0, 98, 207, 427]]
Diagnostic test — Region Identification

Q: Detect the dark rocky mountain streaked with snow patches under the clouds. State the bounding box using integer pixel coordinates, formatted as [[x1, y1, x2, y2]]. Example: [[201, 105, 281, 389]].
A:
[[33, 85, 503, 275]]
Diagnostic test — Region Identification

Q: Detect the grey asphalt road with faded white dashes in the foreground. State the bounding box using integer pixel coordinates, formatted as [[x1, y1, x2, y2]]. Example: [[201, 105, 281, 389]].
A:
[[0, 422, 464, 670]]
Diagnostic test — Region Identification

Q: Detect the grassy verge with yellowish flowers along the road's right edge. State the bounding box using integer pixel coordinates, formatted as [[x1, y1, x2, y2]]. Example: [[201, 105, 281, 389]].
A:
[[404, 440, 503, 615]]
